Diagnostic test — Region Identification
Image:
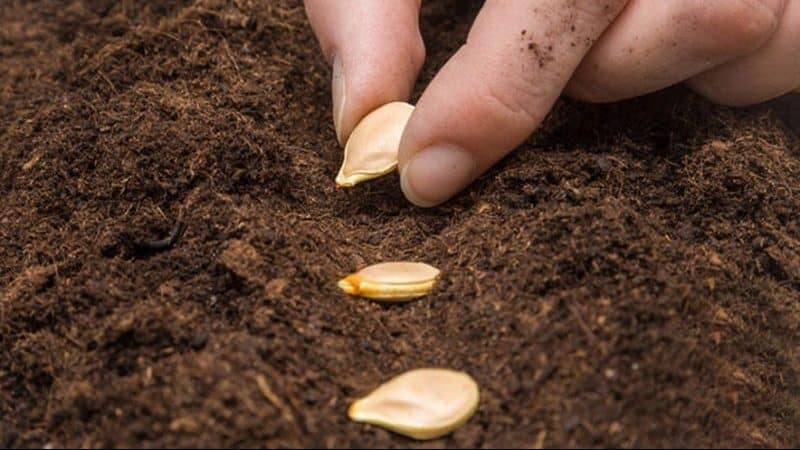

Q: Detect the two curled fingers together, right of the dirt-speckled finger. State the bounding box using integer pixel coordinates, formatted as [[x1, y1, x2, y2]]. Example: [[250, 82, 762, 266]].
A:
[[566, 0, 800, 106]]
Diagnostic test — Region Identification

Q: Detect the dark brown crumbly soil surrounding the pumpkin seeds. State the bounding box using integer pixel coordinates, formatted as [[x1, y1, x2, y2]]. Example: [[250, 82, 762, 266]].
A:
[[0, 0, 800, 447]]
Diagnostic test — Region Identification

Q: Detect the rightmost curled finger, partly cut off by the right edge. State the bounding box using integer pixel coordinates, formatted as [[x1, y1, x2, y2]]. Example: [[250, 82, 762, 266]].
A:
[[687, 0, 800, 106]]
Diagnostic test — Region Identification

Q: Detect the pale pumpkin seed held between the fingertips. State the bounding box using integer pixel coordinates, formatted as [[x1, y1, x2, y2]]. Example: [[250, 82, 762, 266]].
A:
[[336, 102, 414, 187]]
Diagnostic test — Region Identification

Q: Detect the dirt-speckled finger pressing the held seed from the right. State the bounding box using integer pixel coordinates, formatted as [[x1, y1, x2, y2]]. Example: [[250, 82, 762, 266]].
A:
[[399, 0, 625, 206]]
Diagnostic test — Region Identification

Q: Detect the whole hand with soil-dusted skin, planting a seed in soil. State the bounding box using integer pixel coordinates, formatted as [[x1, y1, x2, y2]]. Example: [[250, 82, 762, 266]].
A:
[[305, 0, 800, 207]]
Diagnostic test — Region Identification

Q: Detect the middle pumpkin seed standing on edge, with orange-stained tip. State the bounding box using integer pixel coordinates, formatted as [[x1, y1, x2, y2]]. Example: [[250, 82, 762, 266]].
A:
[[339, 262, 439, 302]]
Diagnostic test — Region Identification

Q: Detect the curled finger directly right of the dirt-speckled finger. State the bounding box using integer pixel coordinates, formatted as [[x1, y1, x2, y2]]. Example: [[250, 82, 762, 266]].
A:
[[567, 0, 784, 102]]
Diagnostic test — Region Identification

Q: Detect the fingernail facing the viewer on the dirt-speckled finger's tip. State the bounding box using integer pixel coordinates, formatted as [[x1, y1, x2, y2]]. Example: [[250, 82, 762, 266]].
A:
[[400, 145, 477, 208]]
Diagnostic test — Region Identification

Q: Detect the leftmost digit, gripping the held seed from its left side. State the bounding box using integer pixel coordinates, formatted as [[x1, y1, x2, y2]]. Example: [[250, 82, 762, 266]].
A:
[[305, 0, 425, 144]]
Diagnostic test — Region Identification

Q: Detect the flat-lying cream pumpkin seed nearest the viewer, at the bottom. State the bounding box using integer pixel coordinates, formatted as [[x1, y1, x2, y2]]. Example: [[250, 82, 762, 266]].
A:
[[347, 369, 480, 440]]
